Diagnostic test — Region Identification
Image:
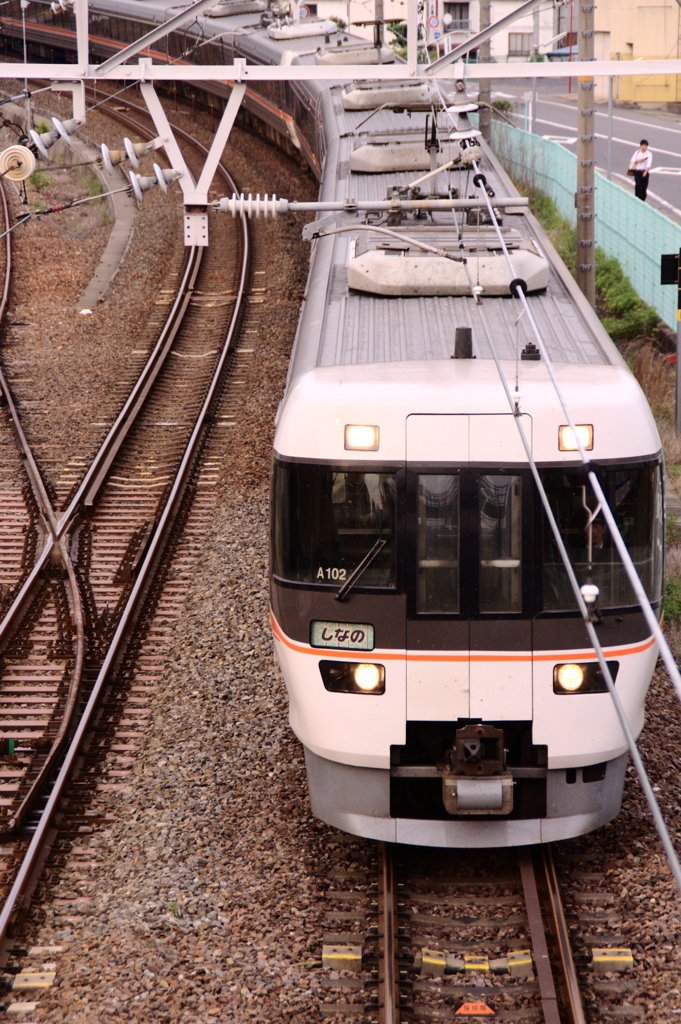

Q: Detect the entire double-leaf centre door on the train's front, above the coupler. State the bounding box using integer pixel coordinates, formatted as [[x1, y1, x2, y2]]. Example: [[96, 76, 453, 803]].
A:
[[406, 415, 533, 721]]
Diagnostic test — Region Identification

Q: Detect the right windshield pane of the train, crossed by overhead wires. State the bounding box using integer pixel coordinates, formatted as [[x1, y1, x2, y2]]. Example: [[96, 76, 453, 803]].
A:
[[542, 466, 663, 611]]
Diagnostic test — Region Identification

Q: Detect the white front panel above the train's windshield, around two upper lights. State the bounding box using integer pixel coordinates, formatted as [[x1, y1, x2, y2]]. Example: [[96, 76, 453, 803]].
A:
[[274, 358, 659, 465]]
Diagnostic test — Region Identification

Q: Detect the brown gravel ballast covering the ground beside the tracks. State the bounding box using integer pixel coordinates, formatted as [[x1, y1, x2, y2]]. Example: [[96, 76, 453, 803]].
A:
[[3, 97, 681, 1024]]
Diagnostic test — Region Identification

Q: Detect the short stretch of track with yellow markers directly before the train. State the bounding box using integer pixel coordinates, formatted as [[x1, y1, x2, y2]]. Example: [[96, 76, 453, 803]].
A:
[[321, 845, 655, 1024]]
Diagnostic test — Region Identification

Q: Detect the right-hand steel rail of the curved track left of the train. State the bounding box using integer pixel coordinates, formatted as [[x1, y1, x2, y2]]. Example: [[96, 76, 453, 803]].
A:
[[0, 130, 251, 962]]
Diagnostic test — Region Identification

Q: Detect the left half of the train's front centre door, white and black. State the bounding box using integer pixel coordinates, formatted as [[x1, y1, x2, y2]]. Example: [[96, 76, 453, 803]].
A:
[[406, 415, 470, 722]]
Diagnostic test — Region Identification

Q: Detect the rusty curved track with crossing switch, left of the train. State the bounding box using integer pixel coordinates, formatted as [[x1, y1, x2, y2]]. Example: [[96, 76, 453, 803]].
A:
[[0, 90, 252, 988]]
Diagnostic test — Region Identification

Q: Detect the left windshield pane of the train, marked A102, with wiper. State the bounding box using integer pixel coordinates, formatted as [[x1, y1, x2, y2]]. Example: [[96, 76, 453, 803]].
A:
[[272, 464, 395, 588]]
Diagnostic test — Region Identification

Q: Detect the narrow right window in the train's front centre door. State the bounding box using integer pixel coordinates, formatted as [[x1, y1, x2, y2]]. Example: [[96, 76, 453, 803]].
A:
[[478, 475, 522, 612]]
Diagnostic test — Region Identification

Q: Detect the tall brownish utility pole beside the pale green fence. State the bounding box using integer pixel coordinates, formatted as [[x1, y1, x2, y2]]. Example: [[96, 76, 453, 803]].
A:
[[574, 0, 596, 306]]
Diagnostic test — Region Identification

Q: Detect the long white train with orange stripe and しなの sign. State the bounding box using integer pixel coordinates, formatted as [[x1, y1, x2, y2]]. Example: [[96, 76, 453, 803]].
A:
[[1, 0, 663, 847]]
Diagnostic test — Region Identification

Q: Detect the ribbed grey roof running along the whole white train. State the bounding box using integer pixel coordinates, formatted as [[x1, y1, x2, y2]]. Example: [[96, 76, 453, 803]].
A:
[[86, 0, 622, 377]]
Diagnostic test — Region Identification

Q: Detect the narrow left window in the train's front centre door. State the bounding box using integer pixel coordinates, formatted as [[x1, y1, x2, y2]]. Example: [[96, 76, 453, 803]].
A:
[[416, 474, 460, 614]]
